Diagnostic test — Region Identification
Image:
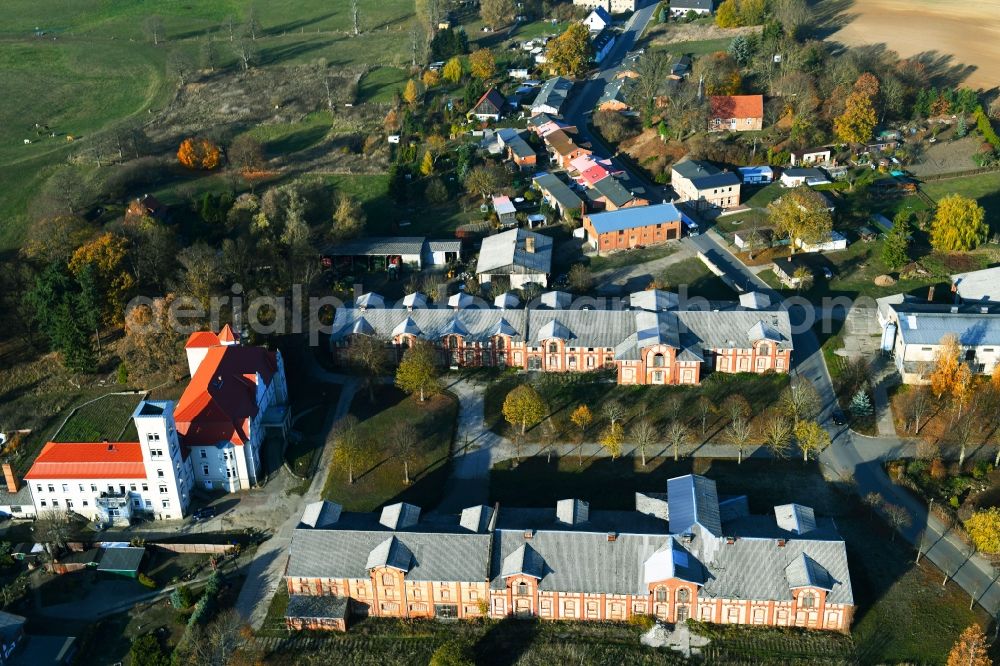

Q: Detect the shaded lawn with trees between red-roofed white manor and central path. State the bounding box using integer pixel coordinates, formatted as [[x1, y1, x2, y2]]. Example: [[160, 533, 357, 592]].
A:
[[323, 386, 458, 511]]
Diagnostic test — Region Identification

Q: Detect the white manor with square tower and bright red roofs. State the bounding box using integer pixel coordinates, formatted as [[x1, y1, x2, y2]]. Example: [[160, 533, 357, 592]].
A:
[[24, 325, 288, 525]]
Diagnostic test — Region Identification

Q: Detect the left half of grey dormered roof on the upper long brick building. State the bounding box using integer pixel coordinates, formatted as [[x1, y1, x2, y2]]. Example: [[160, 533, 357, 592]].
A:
[[330, 308, 527, 342]]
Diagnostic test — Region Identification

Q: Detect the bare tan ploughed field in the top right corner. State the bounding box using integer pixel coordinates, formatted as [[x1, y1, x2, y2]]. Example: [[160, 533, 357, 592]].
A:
[[830, 0, 1000, 89]]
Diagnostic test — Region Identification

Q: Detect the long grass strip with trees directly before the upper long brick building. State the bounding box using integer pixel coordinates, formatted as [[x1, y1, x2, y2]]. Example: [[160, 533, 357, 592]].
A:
[[484, 373, 788, 443]]
